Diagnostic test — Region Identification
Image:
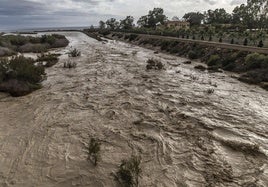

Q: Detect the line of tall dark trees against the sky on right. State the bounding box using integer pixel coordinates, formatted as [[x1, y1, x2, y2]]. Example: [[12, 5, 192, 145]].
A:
[[99, 0, 268, 30]]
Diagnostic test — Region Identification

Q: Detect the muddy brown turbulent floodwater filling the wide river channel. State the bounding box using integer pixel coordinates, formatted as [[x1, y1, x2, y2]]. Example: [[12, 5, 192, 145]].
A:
[[0, 32, 268, 187]]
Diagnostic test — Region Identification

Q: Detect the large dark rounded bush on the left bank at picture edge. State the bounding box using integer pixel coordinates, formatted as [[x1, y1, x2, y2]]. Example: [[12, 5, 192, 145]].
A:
[[0, 56, 45, 96]]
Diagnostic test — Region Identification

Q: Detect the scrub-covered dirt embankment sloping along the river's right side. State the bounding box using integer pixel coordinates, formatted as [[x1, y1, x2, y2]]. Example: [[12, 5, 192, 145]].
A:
[[106, 33, 268, 90]]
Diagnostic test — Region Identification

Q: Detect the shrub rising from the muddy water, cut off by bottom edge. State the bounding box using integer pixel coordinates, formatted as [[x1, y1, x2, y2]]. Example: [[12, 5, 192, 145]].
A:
[[114, 156, 142, 187]]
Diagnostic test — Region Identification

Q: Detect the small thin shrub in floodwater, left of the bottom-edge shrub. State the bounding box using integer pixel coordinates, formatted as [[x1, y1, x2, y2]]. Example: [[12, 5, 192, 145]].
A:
[[88, 138, 101, 166]]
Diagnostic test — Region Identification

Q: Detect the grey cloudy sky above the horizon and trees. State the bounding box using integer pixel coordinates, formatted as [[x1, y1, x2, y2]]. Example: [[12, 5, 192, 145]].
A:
[[0, 0, 246, 30]]
